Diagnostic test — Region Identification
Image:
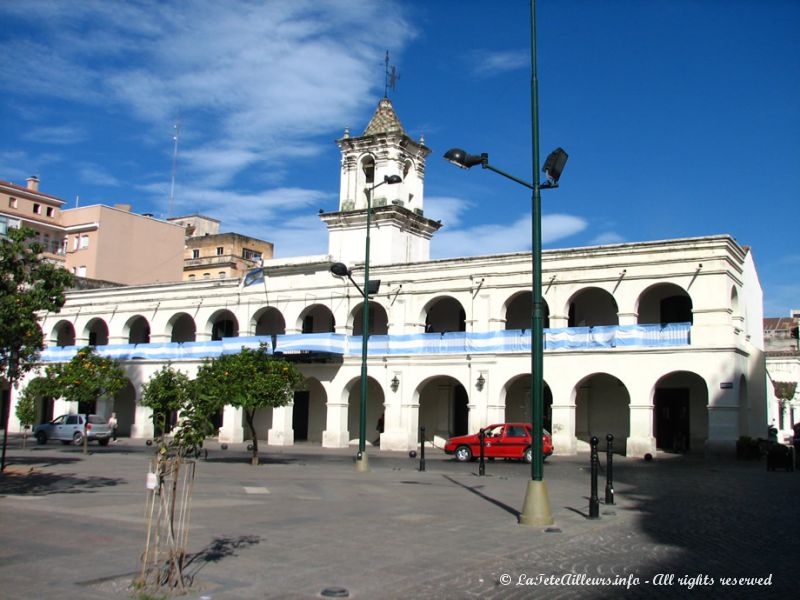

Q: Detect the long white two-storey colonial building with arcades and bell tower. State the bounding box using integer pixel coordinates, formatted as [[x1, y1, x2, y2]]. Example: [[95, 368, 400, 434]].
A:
[[12, 98, 767, 456]]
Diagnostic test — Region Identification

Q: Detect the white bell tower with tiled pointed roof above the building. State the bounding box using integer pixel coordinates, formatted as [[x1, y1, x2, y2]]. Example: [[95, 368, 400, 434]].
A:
[[320, 97, 441, 265]]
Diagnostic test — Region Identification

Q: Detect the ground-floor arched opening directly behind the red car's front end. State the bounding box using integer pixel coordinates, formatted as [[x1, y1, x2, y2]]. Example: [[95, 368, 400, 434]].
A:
[[418, 375, 470, 441]]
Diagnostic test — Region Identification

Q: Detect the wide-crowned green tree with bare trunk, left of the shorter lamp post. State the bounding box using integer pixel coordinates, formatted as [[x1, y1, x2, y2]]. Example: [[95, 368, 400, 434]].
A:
[[195, 344, 304, 465]]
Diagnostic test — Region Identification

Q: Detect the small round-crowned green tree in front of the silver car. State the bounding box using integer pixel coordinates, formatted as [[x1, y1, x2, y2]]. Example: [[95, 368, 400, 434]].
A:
[[46, 346, 128, 453]]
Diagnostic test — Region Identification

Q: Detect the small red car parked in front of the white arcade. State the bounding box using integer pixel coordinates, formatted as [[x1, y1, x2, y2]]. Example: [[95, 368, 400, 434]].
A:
[[444, 423, 553, 463]]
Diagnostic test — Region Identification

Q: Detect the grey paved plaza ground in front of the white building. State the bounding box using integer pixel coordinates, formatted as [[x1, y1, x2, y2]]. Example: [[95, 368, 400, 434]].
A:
[[0, 437, 800, 600]]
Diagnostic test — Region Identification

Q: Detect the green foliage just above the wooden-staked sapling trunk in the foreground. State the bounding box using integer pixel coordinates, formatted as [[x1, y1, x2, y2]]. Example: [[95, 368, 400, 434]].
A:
[[142, 364, 216, 452]]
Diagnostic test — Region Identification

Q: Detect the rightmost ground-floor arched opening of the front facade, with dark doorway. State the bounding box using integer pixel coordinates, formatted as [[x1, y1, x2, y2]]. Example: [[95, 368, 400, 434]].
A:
[[653, 371, 708, 452]]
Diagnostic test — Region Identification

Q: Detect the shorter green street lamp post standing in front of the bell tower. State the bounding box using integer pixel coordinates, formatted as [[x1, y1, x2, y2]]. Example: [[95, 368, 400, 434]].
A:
[[331, 175, 403, 472]]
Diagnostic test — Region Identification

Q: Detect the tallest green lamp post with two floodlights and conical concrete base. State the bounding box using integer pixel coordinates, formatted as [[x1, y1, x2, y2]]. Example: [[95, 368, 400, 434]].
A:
[[444, 0, 568, 526]]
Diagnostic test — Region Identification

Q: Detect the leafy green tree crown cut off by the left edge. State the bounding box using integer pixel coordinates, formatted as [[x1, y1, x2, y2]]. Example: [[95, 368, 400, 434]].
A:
[[0, 228, 73, 381]]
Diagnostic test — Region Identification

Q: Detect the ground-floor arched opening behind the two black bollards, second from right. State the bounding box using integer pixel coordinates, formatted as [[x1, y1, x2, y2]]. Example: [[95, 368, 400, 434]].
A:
[[575, 373, 631, 453]]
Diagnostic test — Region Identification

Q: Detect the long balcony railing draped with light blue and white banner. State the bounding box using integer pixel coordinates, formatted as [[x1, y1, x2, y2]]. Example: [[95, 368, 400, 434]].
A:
[[41, 323, 692, 362]]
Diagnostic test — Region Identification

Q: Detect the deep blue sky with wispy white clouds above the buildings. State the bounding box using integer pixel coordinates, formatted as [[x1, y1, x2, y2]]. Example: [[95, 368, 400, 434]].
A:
[[0, 0, 800, 316]]
